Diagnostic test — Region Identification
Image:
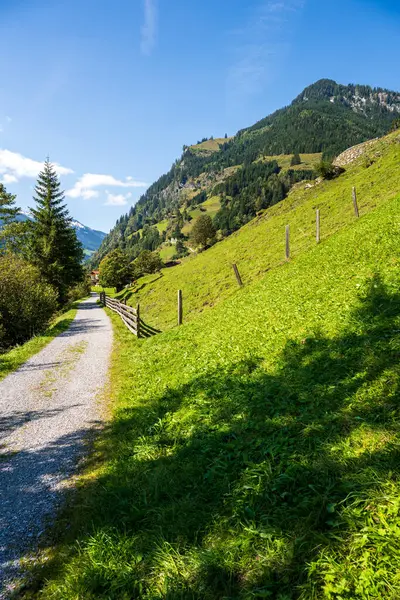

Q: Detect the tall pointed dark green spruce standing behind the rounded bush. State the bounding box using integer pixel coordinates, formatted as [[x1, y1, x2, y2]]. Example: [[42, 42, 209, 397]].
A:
[[30, 159, 83, 303]]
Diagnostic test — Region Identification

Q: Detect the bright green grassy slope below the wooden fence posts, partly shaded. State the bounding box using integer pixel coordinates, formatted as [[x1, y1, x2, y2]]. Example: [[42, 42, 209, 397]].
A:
[[25, 191, 400, 600]]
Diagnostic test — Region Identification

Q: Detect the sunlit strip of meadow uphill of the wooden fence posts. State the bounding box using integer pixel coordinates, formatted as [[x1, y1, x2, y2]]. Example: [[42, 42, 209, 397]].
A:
[[117, 132, 400, 330]]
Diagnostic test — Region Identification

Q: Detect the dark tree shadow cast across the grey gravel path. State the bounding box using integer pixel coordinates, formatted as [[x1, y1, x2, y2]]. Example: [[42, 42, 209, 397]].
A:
[[0, 424, 98, 597]]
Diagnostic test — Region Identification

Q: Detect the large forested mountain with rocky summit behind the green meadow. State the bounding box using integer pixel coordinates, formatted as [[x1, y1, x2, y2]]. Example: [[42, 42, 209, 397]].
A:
[[92, 79, 400, 266]]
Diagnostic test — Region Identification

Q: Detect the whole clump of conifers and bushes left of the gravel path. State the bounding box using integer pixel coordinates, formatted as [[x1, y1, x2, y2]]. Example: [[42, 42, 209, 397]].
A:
[[0, 159, 84, 351]]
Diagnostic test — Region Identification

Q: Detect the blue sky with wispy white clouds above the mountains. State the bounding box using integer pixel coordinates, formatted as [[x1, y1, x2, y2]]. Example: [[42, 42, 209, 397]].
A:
[[0, 0, 400, 231]]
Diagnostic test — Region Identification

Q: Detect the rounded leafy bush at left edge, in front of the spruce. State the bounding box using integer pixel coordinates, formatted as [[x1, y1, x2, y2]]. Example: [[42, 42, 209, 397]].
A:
[[0, 254, 57, 350]]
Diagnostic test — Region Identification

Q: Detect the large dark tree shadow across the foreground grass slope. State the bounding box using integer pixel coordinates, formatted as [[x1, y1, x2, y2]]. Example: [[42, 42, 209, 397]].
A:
[[21, 278, 400, 600]]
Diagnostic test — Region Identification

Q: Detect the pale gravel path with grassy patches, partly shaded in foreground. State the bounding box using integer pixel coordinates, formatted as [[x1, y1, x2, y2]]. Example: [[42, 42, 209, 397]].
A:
[[0, 295, 112, 599]]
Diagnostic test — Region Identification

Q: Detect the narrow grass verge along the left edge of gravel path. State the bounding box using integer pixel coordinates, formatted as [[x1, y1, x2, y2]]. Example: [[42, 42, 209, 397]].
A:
[[0, 301, 80, 380]]
